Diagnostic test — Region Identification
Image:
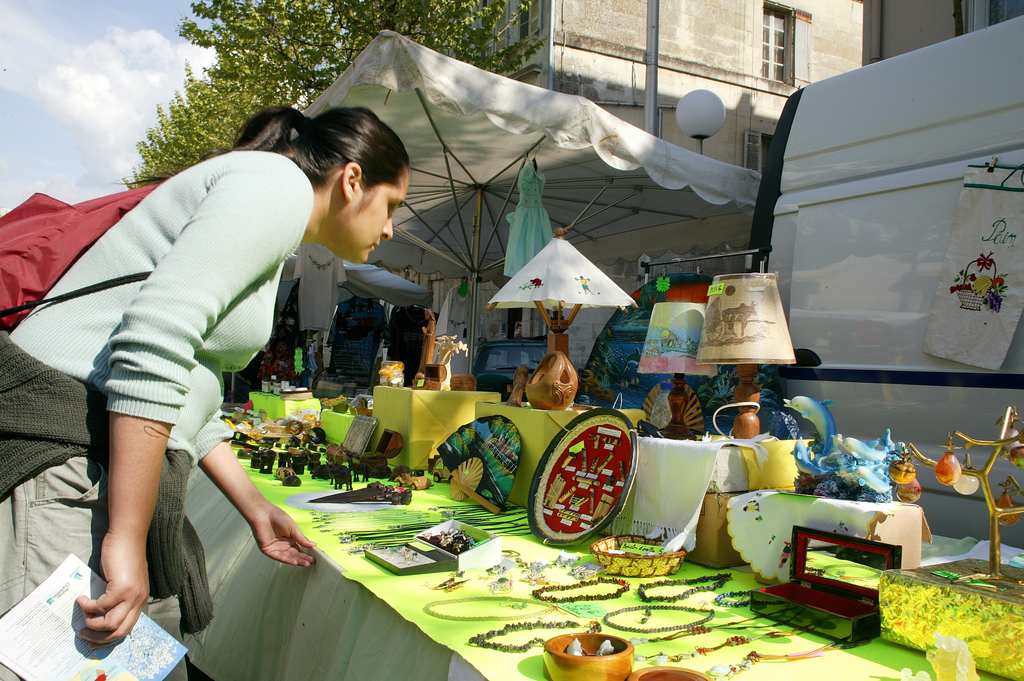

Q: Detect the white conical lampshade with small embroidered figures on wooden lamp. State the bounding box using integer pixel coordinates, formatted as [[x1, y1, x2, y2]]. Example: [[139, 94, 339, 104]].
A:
[[488, 239, 636, 308]]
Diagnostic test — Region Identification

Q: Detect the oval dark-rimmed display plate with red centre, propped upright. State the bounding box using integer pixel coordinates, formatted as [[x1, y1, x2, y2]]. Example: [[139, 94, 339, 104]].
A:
[[527, 409, 637, 545]]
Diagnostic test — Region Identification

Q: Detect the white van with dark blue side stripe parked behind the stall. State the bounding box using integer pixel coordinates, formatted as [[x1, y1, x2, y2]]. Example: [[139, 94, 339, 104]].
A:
[[752, 17, 1024, 546]]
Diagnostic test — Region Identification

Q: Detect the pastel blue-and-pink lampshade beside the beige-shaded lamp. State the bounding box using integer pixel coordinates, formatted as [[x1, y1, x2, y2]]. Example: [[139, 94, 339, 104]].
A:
[[637, 302, 715, 376]]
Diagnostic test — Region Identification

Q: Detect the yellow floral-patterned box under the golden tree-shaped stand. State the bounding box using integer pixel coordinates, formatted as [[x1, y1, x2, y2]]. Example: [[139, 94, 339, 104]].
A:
[[879, 560, 1024, 681]]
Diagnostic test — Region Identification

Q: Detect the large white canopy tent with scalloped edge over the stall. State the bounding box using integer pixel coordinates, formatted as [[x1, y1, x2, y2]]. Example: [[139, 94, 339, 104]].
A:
[[306, 32, 759, 356]]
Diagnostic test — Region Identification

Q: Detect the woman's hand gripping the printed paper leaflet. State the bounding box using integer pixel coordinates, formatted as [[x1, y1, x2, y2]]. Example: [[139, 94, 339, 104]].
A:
[[78, 533, 150, 645]]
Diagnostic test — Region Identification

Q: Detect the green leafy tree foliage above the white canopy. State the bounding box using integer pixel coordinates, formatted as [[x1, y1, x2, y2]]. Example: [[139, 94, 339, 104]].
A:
[[132, 0, 540, 181]]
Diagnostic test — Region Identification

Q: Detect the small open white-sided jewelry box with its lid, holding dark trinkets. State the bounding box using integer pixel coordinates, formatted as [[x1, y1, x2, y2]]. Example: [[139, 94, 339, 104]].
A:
[[362, 520, 502, 574]]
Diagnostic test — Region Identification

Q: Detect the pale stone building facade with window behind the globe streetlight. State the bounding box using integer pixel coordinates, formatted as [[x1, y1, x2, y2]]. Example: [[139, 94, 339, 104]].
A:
[[499, 0, 863, 169]]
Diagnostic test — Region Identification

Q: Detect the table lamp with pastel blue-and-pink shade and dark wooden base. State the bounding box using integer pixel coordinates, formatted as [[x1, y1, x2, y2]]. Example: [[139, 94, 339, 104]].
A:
[[637, 302, 715, 439]]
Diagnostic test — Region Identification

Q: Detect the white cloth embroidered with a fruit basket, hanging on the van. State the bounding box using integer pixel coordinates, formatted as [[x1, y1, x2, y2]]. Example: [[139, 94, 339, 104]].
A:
[[925, 165, 1024, 369]]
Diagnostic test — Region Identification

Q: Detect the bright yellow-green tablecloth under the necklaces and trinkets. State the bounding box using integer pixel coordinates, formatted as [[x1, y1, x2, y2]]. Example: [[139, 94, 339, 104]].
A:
[[224, 464, 993, 681]]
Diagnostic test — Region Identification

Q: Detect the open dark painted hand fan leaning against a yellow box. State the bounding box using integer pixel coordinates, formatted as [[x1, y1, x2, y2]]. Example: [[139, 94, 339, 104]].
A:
[[437, 416, 522, 513]]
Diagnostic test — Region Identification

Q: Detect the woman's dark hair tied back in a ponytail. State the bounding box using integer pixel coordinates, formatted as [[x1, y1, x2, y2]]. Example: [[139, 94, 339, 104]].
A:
[[234, 107, 410, 187]]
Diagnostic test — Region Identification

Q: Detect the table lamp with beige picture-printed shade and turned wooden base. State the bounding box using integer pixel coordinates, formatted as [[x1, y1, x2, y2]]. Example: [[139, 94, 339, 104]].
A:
[[696, 272, 797, 439]]
